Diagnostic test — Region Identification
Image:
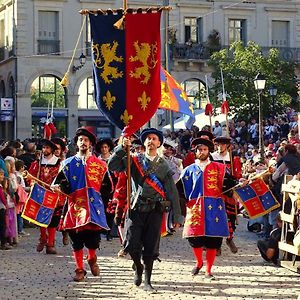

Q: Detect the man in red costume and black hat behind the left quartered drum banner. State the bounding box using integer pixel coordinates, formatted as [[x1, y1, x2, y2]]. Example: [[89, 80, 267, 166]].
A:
[[28, 139, 62, 254]]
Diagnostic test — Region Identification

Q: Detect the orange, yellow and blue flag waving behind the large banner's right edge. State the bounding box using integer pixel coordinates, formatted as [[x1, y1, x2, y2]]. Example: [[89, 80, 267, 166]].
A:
[[159, 67, 196, 128]]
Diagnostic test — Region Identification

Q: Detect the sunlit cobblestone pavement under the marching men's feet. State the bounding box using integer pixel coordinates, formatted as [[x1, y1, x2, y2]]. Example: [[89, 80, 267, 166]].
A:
[[0, 219, 300, 300]]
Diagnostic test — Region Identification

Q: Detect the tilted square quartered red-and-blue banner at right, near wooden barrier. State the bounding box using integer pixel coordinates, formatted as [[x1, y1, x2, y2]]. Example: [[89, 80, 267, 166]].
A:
[[234, 178, 280, 219]]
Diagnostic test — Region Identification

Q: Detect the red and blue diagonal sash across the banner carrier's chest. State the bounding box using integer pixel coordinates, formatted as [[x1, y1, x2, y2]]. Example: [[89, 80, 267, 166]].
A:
[[132, 155, 166, 199]]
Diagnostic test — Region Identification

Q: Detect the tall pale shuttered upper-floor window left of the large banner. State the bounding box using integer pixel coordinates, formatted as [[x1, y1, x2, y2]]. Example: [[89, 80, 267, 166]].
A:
[[38, 11, 59, 54]]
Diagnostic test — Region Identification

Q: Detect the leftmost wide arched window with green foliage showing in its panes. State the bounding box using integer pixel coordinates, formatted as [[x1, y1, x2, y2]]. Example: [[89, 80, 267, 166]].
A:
[[31, 75, 66, 108]]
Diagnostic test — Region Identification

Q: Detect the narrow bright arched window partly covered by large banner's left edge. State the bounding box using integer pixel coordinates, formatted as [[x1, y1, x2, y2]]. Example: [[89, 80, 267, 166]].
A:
[[78, 77, 97, 109]]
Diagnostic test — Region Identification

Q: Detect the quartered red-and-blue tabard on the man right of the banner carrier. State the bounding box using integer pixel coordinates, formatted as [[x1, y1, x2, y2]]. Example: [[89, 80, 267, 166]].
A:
[[181, 162, 229, 238]]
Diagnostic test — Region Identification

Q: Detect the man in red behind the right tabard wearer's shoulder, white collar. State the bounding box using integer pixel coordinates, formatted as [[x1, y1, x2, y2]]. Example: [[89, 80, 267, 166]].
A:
[[211, 136, 242, 255]]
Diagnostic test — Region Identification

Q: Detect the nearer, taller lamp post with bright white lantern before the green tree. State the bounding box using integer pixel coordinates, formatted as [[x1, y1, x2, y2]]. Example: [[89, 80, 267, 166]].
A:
[[254, 73, 266, 163]]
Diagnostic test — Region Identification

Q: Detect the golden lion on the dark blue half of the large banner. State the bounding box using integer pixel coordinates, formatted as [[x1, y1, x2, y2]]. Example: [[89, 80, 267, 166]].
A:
[[93, 41, 123, 84]]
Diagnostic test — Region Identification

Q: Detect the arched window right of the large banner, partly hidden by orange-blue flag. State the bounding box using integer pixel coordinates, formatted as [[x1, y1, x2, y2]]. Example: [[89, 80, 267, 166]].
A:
[[182, 78, 205, 109]]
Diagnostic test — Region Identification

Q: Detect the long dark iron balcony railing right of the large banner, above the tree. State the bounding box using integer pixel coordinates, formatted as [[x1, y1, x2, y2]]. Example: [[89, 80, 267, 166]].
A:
[[170, 44, 300, 63]]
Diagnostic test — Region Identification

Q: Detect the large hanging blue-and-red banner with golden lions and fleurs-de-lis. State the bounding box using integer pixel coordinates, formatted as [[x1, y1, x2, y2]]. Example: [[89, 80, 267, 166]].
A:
[[89, 12, 161, 136]]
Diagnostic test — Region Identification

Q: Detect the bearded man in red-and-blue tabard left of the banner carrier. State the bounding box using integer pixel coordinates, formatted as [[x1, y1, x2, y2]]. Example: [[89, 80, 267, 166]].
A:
[[53, 127, 109, 282]]
